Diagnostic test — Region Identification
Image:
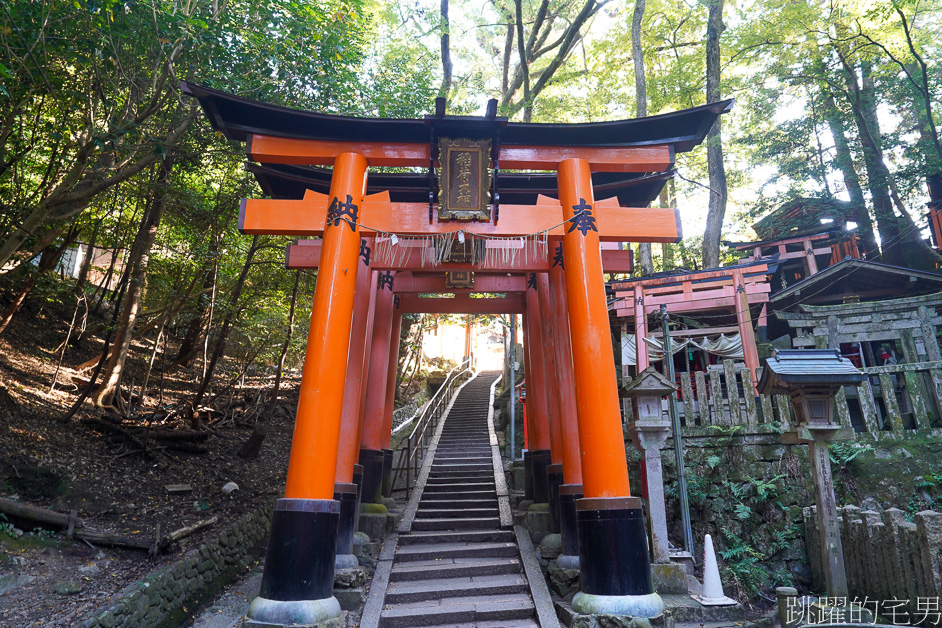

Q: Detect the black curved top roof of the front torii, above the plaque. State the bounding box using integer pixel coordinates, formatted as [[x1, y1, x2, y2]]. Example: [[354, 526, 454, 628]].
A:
[[180, 81, 734, 152]]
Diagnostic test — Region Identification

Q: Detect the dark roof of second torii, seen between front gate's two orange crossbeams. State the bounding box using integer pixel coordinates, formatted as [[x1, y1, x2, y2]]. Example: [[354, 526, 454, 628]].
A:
[[245, 162, 673, 207]]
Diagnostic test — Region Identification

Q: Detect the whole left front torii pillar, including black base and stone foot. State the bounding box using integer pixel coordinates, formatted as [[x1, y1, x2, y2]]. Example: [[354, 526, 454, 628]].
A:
[[245, 153, 367, 626]]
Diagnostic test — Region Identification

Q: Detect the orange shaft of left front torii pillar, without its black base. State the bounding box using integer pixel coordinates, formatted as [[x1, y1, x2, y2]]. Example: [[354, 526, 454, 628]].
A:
[[285, 153, 366, 499]]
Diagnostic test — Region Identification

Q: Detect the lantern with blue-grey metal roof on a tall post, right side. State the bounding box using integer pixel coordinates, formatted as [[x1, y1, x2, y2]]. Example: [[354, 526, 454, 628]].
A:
[[757, 349, 866, 598]]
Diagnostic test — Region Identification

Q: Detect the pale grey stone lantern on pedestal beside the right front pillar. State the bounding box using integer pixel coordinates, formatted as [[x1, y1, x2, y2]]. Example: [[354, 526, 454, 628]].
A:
[[621, 366, 677, 563]]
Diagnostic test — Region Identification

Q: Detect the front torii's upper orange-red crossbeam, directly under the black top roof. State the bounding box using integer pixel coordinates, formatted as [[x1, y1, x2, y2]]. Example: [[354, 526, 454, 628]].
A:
[[246, 135, 674, 172]]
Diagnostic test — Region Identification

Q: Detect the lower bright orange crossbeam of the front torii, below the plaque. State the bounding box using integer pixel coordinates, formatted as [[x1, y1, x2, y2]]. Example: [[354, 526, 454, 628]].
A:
[[239, 193, 682, 243]]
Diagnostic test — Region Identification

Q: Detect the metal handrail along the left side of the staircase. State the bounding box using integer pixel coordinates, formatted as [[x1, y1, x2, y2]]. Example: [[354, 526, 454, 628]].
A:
[[392, 358, 474, 499]]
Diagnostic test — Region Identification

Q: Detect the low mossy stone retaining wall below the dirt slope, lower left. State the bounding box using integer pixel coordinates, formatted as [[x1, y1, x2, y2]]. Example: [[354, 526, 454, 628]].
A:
[[81, 501, 274, 628]]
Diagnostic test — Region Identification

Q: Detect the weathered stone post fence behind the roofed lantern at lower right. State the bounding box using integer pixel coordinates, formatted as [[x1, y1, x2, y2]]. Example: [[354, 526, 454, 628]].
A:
[[804, 506, 942, 604]]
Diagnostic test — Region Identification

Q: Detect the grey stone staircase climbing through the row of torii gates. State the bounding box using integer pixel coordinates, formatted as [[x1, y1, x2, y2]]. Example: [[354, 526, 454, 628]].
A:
[[372, 372, 540, 628]]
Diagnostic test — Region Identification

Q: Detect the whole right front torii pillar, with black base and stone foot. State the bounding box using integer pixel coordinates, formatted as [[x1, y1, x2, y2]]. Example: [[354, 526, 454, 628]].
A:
[[557, 159, 664, 617]]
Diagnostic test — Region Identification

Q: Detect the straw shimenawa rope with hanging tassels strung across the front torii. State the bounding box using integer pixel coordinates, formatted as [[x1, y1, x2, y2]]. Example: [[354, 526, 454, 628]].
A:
[[340, 210, 586, 268]]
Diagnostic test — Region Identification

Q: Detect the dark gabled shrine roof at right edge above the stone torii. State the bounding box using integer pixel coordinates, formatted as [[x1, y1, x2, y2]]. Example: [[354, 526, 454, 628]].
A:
[[769, 258, 942, 309]]
